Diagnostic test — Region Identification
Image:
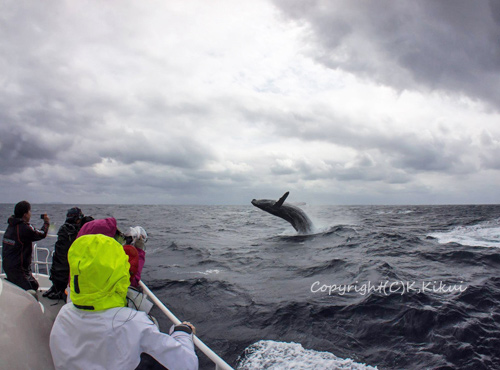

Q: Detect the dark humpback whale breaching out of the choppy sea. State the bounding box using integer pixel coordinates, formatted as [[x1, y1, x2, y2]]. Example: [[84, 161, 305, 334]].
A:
[[252, 191, 313, 234]]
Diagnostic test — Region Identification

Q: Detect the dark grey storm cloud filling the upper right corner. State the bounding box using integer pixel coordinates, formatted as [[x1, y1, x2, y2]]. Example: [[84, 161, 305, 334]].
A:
[[274, 0, 500, 109]]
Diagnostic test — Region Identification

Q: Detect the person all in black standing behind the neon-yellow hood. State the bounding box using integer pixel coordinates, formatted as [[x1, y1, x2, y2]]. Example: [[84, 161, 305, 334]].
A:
[[43, 207, 93, 300]]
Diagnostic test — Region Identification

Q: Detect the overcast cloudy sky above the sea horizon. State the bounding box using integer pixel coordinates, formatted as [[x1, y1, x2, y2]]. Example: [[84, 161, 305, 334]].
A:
[[0, 0, 500, 204]]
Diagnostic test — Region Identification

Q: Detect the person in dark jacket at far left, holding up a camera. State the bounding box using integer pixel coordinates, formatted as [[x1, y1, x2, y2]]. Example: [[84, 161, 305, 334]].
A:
[[2, 200, 50, 291]]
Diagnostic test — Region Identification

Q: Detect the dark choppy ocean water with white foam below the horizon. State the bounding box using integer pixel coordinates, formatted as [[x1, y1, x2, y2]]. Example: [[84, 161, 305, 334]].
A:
[[0, 204, 500, 369]]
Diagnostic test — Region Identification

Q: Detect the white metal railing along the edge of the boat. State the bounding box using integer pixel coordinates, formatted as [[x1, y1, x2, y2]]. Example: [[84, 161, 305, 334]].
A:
[[0, 236, 234, 370]]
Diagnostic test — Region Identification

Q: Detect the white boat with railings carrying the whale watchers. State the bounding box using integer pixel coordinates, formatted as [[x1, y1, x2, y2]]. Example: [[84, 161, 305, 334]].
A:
[[0, 237, 234, 370]]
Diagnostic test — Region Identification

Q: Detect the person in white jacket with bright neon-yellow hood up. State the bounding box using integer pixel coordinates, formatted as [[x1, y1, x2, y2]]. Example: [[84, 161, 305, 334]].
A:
[[50, 234, 198, 370]]
